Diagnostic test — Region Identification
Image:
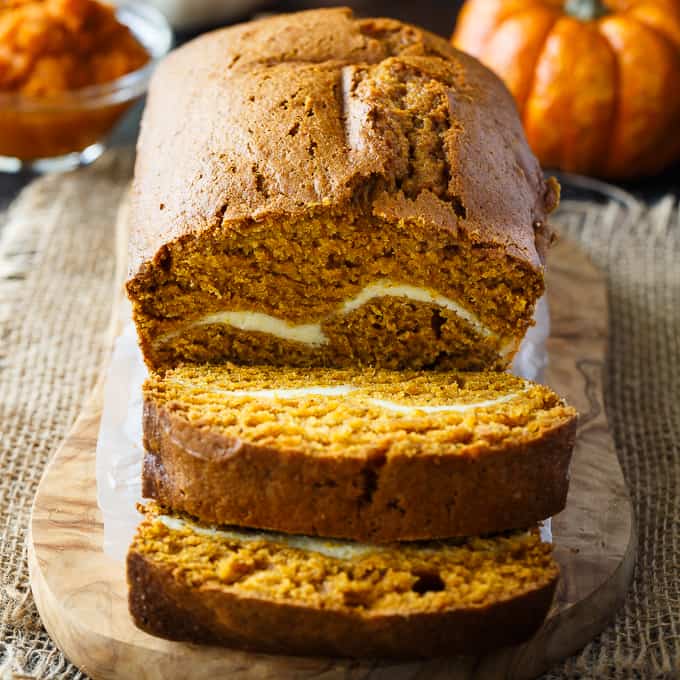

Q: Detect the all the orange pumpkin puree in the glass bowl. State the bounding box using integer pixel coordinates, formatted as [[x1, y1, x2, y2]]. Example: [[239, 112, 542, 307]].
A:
[[0, 0, 150, 161]]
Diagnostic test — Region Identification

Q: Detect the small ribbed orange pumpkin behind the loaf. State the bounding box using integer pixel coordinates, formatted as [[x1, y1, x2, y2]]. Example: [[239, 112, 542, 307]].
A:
[[452, 0, 680, 179]]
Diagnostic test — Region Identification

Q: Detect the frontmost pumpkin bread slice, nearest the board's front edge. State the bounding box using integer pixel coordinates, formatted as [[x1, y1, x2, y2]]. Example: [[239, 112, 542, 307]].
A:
[[127, 505, 559, 658]]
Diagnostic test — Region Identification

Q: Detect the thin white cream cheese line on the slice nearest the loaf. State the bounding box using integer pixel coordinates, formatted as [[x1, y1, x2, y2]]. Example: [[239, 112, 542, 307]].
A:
[[163, 379, 530, 415]]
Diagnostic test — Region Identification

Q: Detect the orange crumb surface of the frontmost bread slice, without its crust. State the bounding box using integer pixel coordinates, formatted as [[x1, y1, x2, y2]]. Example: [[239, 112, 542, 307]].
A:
[[130, 504, 558, 614]]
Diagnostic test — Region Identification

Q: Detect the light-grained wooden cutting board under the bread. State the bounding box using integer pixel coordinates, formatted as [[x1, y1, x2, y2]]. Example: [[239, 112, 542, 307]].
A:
[[29, 235, 636, 680]]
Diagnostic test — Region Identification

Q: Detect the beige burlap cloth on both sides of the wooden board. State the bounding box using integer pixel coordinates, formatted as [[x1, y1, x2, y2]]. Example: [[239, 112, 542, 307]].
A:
[[0, 152, 680, 680]]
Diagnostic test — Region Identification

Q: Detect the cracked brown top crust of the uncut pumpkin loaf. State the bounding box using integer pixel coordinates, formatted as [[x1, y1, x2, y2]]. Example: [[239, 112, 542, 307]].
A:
[[130, 9, 558, 276]]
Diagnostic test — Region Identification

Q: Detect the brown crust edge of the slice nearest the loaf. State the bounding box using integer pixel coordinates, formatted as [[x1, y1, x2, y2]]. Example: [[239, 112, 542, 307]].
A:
[[142, 399, 576, 542]]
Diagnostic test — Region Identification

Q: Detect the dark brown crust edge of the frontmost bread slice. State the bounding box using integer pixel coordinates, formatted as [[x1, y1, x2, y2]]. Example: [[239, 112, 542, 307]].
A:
[[127, 547, 557, 658]]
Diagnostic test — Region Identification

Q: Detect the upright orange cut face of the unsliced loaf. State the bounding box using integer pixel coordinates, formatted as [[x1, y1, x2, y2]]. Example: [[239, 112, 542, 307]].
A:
[[129, 212, 543, 369]]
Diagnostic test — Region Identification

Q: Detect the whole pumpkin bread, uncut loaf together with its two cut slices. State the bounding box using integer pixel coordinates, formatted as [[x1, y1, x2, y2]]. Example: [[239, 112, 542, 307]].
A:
[[127, 9, 576, 658]]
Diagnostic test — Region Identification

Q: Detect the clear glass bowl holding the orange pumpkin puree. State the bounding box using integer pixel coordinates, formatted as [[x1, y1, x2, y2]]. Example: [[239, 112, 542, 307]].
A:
[[0, 0, 172, 172]]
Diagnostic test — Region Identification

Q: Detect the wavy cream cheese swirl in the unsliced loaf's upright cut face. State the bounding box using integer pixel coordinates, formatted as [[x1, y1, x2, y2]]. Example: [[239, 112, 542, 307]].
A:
[[154, 279, 520, 358]]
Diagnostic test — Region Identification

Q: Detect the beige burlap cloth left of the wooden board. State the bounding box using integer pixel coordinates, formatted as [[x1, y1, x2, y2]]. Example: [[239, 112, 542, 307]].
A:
[[0, 153, 132, 680]]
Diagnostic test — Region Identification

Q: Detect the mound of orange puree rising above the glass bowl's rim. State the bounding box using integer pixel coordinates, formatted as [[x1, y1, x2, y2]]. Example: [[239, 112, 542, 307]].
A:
[[0, 0, 149, 97]]
